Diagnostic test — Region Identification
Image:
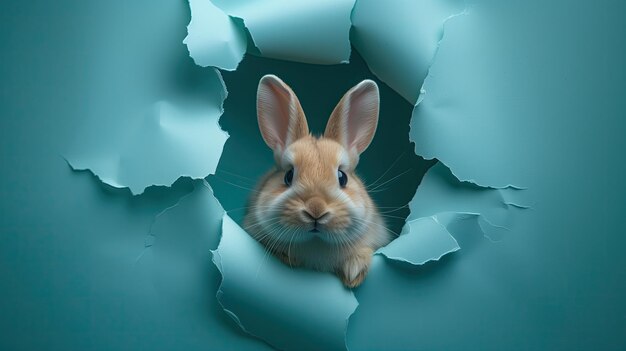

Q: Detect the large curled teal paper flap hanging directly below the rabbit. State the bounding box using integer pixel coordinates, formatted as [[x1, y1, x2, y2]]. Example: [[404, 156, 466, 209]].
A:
[[213, 215, 358, 350]]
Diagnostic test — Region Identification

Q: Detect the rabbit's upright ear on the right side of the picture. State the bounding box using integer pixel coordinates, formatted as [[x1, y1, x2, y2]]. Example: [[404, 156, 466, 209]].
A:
[[324, 79, 380, 154]]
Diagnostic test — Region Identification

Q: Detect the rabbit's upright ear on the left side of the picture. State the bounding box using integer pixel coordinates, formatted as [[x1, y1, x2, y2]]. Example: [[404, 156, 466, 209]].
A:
[[256, 74, 309, 153]]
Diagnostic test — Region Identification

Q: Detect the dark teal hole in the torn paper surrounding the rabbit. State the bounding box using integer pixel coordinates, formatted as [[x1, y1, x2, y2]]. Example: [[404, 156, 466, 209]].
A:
[[209, 49, 434, 239]]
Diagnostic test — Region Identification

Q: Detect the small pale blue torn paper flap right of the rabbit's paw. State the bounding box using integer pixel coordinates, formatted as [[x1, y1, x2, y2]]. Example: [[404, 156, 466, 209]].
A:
[[377, 216, 460, 265]]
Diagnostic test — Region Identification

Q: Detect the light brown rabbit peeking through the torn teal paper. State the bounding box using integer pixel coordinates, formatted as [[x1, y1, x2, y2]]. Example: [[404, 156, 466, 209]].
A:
[[243, 75, 391, 288]]
